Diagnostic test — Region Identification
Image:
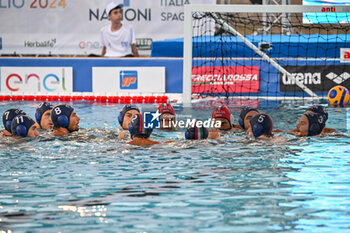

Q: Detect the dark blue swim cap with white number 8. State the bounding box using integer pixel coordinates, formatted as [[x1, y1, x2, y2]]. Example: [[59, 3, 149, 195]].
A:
[[51, 104, 74, 129]]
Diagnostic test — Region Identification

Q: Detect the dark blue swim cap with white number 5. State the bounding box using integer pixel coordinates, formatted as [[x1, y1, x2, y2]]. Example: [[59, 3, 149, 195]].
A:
[[249, 113, 273, 138]]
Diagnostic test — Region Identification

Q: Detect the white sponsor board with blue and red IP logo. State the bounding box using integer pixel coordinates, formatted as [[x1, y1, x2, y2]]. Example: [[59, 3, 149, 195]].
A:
[[92, 67, 165, 95]]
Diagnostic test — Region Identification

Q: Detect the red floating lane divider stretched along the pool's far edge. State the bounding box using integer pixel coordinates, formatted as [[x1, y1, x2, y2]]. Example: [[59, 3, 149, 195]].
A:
[[0, 95, 169, 104]]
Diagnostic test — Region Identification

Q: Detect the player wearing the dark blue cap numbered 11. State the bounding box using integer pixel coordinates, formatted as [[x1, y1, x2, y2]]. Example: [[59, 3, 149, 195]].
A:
[[11, 115, 39, 137]]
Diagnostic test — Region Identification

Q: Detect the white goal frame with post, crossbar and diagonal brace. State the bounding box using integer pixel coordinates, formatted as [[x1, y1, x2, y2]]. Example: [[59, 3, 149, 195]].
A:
[[183, 4, 350, 104]]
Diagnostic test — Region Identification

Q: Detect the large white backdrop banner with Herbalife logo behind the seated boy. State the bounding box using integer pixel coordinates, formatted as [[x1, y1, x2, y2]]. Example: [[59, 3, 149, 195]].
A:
[[0, 0, 216, 55]]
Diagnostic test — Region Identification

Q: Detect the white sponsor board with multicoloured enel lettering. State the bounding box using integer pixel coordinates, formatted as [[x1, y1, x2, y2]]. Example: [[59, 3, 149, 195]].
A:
[[0, 67, 73, 95]]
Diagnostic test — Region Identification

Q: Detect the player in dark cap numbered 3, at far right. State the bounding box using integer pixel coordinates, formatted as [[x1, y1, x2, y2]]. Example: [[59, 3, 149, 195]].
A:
[[294, 113, 325, 137]]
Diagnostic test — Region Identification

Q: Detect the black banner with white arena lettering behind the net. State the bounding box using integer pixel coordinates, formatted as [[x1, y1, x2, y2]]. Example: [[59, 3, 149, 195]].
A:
[[280, 65, 350, 92]]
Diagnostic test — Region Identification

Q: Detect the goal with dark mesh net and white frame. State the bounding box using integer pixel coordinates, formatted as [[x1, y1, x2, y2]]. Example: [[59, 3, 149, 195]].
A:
[[183, 5, 350, 102]]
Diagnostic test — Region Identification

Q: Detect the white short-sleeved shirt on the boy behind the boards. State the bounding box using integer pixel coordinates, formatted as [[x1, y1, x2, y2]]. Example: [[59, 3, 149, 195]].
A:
[[100, 24, 136, 57]]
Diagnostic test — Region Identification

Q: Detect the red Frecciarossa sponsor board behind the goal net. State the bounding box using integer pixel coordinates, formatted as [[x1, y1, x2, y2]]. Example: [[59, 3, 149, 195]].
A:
[[192, 66, 259, 93]]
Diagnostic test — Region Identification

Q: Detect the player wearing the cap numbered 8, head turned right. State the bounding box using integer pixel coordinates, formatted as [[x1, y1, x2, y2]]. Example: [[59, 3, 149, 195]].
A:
[[51, 104, 80, 136]]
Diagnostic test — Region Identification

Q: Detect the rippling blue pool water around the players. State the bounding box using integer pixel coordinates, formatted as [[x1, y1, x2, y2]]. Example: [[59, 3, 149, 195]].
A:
[[0, 102, 350, 232]]
